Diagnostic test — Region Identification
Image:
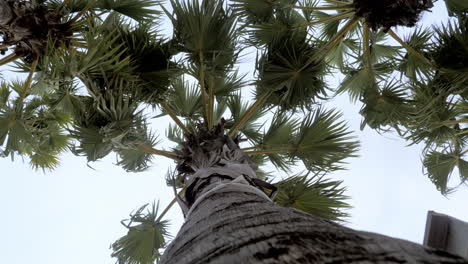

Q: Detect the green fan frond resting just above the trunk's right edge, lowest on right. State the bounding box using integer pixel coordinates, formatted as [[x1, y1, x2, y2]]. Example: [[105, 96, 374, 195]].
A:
[[274, 174, 351, 221]]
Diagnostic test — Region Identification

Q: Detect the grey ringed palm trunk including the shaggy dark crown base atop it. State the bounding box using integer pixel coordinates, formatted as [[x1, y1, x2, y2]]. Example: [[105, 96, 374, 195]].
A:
[[163, 120, 468, 264]]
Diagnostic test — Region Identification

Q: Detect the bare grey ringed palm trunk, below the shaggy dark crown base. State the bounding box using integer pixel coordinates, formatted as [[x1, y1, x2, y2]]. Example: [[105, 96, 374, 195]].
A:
[[159, 164, 468, 264]]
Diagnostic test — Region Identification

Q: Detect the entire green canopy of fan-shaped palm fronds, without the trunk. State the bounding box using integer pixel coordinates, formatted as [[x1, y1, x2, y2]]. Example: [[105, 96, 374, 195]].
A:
[[0, 0, 468, 263]]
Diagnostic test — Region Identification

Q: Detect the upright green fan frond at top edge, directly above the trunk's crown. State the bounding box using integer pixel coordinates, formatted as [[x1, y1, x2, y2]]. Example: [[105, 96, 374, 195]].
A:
[[165, 0, 239, 72]]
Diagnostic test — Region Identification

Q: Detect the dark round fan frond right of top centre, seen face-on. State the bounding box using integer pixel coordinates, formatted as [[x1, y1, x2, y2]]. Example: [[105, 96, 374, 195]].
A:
[[256, 38, 327, 110]]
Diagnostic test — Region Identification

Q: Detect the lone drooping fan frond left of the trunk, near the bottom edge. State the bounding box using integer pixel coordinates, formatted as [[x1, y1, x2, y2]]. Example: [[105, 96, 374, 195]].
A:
[[112, 203, 169, 264]]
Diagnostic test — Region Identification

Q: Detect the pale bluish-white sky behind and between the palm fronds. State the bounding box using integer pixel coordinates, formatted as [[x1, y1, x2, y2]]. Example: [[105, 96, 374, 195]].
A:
[[0, 1, 468, 264]]
